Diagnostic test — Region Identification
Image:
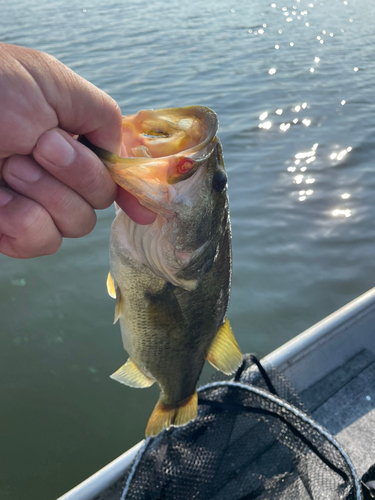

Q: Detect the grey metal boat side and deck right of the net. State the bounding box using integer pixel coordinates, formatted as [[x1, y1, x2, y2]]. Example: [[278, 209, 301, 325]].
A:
[[266, 288, 375, 484]]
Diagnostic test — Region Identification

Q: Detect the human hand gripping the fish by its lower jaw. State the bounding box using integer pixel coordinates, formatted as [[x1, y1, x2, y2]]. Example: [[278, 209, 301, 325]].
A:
[[0, 43, 156, 258]]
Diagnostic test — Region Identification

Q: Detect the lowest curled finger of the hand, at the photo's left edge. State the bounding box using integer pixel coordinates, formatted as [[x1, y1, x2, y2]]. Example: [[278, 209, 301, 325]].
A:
[[0, 188, 62, 259]]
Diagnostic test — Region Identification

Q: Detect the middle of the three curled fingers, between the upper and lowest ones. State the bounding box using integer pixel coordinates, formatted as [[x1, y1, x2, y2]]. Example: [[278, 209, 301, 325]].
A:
[[3, 155, 96, 238]]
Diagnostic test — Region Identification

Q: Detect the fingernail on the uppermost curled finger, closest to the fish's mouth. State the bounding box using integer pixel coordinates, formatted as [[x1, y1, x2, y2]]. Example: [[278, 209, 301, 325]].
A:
[[37, 130, 75, 167]]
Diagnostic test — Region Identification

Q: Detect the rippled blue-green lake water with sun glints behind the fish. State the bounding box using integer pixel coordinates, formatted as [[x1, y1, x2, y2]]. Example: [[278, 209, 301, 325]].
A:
[[0, 0, 375, 500]]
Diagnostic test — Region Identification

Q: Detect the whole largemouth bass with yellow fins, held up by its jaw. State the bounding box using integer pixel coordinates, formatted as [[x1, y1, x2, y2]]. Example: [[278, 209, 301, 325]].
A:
[[85, 106, 242, 436]]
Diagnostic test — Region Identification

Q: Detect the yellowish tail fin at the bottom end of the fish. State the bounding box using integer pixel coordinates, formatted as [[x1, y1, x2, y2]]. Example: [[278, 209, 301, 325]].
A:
[[146, 391, 198, 437]]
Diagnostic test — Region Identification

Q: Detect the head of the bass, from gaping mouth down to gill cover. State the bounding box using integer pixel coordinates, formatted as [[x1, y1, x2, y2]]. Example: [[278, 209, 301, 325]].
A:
[[96, 106, 229, 288]]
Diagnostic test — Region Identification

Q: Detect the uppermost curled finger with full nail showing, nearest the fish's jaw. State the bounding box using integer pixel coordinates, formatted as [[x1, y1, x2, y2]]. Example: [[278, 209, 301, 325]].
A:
[[33, 128, 117, 208]]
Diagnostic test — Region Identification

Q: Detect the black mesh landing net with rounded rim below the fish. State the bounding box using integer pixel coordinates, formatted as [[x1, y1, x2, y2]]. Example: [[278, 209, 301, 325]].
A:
[[96, 355, 362, 500]]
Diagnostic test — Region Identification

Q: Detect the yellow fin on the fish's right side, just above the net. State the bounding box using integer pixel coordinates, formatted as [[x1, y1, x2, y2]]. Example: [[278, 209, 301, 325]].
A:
[[207, 318, 242, 375]]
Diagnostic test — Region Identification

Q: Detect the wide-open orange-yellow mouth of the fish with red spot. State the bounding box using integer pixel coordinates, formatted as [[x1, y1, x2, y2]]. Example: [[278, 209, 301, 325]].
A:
[[82, 106, 218, 216]]
